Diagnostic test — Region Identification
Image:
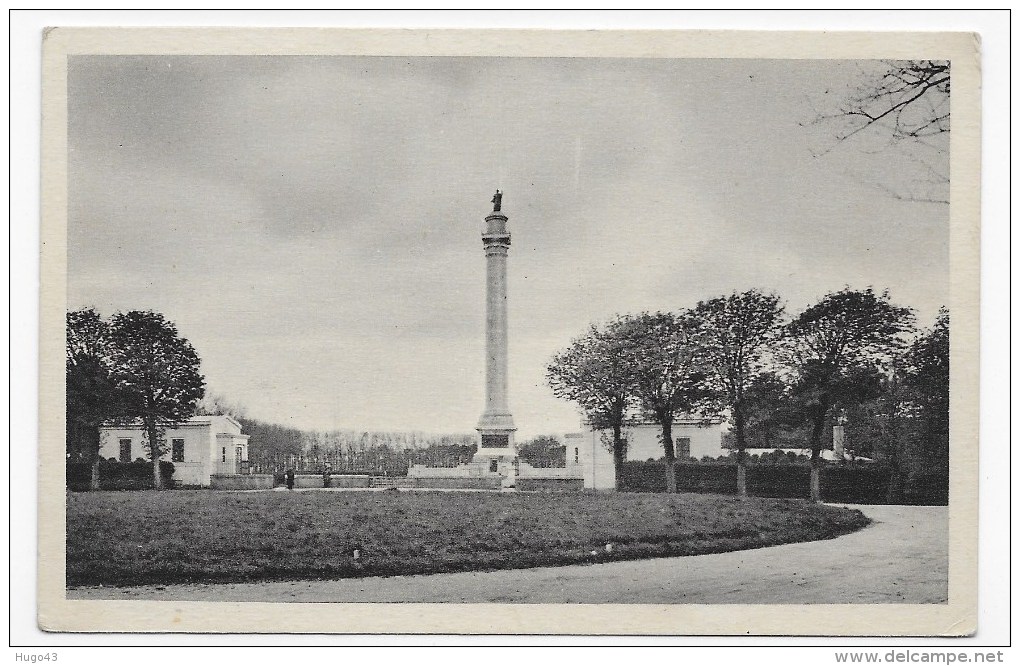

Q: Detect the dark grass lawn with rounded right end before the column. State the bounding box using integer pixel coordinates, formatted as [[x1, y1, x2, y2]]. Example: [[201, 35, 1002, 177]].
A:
[[67, 491, 868, 585]]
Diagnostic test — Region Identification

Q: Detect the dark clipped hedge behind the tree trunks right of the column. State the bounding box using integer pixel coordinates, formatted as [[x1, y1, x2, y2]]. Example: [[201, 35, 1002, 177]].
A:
[[620, 461, 949, 505]]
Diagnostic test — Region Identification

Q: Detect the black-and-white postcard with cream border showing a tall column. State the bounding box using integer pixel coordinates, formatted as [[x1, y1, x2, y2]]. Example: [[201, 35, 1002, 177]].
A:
[[40, 24, 979, 635]]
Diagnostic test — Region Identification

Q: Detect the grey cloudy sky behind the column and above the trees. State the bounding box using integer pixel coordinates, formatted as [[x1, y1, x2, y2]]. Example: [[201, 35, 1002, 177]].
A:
[[68, 56, 949, 438]]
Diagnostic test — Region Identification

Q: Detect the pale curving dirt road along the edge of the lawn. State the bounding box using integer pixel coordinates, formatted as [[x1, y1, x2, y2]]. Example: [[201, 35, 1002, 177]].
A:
[[67, 506, 949, 604]]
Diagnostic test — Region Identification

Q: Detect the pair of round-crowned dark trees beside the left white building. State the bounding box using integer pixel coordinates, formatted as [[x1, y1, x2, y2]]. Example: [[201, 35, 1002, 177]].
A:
[[65, 308, 205, 490]]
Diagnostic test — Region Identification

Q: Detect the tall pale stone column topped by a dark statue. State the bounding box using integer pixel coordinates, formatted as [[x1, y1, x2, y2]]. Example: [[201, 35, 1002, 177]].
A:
[[475, 190, 517, 465]]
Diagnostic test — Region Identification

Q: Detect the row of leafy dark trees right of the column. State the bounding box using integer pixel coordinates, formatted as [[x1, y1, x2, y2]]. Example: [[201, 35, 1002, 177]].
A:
[[547, 288, 949, 501]]
